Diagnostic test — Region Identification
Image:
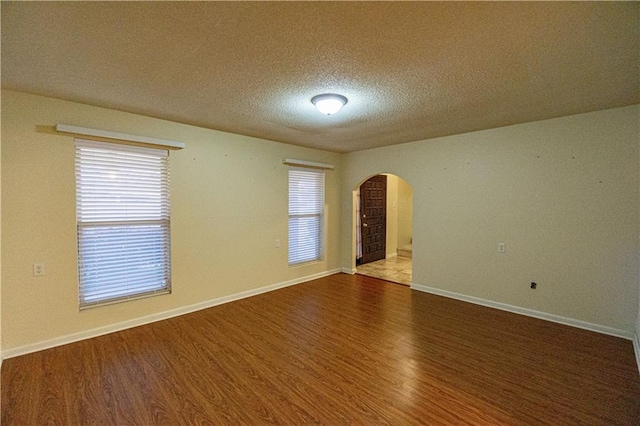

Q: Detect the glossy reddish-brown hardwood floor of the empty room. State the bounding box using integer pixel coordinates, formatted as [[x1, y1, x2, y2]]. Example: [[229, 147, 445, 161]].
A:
[[1, 274, 640, 425]]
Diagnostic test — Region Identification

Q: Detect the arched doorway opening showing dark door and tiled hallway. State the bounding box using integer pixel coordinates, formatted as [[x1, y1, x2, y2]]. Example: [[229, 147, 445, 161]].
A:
[[353, 173, 413, 285]]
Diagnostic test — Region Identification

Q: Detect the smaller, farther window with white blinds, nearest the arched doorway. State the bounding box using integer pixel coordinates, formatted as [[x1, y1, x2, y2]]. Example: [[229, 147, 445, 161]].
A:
[[289, 167, 324, 265]]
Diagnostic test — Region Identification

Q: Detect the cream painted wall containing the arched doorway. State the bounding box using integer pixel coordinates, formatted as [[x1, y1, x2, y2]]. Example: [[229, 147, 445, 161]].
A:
[[342, 105, 640, 336]]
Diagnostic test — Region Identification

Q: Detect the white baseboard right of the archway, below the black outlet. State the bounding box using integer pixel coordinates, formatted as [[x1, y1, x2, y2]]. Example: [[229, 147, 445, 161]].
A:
[[411, 283, 638, 340]]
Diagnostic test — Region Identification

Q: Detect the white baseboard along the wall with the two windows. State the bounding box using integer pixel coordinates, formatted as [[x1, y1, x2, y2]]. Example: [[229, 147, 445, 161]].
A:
[[0, 269, 342, 362]]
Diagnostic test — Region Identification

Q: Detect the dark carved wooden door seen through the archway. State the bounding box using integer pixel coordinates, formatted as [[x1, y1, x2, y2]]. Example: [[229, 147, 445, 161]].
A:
[[360, 175, 387, 263]]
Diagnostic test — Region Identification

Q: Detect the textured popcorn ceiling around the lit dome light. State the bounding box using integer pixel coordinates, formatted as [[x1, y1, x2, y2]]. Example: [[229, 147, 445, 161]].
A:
[[2, 2, 640, 152]]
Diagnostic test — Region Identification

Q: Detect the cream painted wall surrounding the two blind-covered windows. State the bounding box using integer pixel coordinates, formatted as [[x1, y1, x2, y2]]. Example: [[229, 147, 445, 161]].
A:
[[1, 90, 341, 351]]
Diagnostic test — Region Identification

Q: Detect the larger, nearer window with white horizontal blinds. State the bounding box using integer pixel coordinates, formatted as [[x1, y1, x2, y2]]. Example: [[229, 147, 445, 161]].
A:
[[76, 140, 171, 309]]
